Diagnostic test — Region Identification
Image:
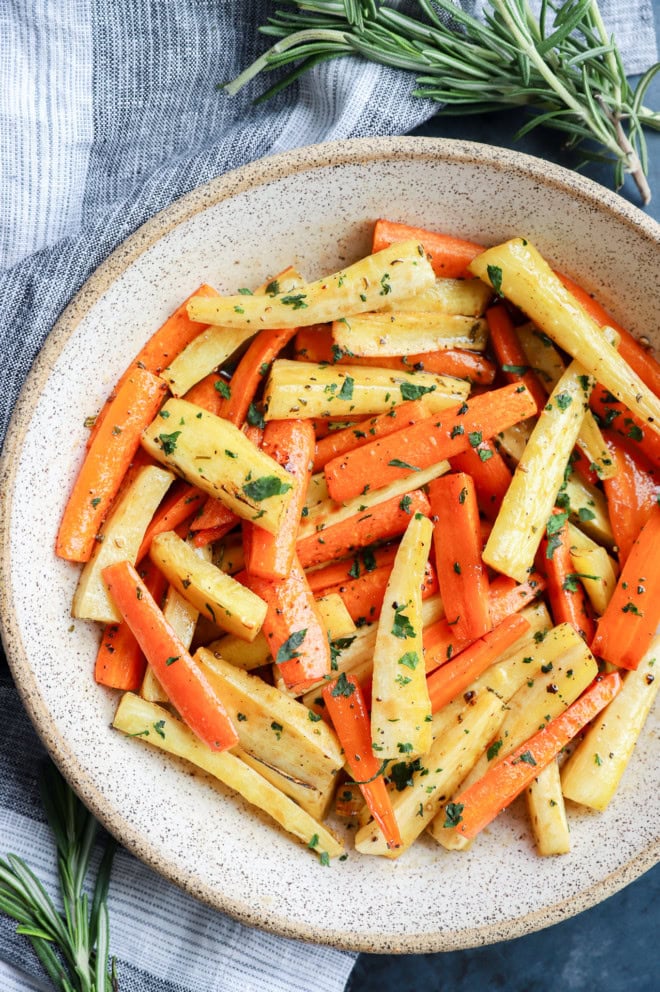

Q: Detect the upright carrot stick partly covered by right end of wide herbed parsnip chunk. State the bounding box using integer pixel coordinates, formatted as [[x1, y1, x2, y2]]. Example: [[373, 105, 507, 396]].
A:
[[243, 420, 316, 579]]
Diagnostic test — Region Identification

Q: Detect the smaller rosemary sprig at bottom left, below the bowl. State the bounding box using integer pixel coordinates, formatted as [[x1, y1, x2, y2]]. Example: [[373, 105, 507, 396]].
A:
[[0, 765, 118, 992]]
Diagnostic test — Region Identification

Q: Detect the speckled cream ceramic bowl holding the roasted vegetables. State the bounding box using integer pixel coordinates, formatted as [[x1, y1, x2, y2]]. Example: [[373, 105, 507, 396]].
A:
[[0, 138, 660, 952]]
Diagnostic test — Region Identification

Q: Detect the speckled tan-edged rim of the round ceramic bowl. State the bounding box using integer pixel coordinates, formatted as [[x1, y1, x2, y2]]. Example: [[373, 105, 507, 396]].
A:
[[0, 137, 660, 953]]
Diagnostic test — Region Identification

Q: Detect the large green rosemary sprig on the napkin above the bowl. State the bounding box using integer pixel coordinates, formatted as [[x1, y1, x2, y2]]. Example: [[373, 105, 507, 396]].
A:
[[225, 0, 660, 204]]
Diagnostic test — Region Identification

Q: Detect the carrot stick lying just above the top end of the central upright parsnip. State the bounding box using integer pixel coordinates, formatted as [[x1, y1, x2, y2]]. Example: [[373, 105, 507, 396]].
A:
[[297, 489, 430, 568]]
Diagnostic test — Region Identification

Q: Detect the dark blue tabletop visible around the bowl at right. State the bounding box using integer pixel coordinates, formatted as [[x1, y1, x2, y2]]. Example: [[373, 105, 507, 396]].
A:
[[347, 13, 660, 992]]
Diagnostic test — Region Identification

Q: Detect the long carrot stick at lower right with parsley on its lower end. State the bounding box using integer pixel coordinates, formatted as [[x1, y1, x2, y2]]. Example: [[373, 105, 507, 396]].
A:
[[445, 672, 623, 840]]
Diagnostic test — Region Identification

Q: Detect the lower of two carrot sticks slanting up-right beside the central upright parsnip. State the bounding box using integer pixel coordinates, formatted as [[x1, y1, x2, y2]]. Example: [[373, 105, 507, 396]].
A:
[[425, 614, 529, 713]]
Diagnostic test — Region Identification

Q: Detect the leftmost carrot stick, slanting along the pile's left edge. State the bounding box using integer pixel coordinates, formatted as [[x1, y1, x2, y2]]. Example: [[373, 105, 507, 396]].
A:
[[55, 369, 167, 561]]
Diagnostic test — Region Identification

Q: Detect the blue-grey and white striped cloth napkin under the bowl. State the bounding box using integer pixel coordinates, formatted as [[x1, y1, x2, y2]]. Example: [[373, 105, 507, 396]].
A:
[[0, 0, 655, 992]]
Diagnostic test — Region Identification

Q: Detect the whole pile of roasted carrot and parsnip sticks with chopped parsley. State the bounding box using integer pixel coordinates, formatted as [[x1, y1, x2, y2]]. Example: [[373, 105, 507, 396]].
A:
[[56, 220, 660, 864]]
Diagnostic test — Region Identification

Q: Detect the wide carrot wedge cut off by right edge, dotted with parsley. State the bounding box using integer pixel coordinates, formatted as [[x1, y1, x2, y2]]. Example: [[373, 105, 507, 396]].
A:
[[591, 504, 660, 669]]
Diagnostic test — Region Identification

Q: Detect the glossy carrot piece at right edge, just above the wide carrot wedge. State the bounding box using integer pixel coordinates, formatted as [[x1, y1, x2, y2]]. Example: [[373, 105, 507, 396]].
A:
[[603, 431, 660, 565]]
